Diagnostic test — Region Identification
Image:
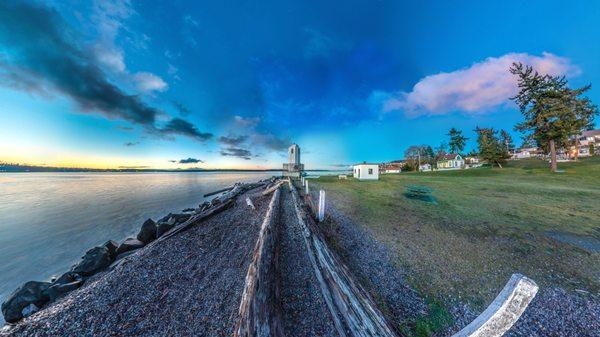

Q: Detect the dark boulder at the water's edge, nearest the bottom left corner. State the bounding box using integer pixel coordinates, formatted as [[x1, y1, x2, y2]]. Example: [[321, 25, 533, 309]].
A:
[[2, 281, 51, 323]]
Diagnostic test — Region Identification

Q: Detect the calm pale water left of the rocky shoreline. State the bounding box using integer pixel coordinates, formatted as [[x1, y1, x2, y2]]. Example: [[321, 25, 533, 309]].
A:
[[0, 172, 276, 323]]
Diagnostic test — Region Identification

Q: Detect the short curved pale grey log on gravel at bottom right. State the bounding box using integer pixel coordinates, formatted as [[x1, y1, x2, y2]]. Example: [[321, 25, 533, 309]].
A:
[[453, 274, 538, 337]]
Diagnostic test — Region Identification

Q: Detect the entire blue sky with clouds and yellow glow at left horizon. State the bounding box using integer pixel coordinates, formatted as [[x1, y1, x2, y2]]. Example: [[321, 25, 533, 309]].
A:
[[0, 0, 600, 169]]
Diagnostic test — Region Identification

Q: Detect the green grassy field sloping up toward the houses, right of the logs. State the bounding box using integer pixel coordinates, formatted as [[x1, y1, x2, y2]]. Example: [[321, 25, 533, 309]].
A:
[[314, 157, 600, 309]]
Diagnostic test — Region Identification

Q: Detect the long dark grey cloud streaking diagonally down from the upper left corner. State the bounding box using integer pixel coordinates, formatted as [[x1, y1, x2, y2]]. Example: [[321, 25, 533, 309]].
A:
[[0, 1, 212, 140]]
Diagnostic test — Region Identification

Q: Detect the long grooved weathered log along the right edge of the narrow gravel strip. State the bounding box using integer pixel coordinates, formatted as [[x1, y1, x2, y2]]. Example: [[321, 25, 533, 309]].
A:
[[290, 182, 396, 337]]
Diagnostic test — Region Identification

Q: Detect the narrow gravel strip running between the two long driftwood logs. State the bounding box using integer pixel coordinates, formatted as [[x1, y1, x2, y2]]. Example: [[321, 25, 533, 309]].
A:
[[279, 186, 337, 337]]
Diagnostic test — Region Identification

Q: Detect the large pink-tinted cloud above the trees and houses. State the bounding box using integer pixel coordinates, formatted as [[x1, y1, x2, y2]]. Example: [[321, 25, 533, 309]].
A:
[[376, 52, 581, 116]]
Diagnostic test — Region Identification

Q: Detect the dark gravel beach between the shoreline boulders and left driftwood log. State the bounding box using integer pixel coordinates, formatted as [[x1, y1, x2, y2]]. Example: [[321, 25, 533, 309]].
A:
[[0, 186, 270, 337]]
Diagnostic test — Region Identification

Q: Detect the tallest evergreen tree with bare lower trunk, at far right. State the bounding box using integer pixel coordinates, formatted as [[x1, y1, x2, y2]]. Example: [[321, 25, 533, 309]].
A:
[[510, 63, 598, 172]]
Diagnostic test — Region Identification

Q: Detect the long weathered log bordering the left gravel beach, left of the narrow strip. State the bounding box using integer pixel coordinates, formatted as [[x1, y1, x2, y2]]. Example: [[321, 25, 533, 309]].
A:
[[233, 189, 284, 337]]
